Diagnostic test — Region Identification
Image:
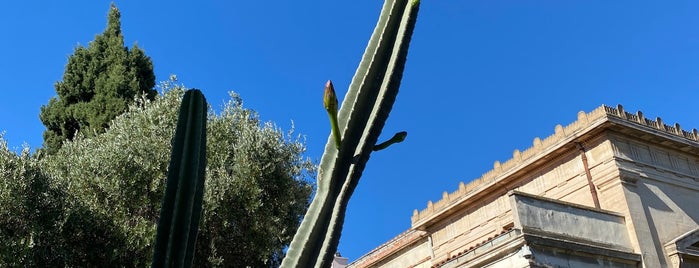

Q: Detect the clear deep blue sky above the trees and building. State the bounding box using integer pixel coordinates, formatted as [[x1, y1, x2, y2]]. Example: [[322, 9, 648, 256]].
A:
[[0, 0, 699, 260]]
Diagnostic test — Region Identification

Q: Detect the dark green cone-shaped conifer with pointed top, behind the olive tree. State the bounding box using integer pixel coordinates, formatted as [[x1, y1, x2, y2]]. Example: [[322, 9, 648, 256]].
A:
[[39, 3, 157, 154]]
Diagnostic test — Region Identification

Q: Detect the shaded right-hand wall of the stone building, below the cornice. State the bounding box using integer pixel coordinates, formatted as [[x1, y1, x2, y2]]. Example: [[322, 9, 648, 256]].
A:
[[612, 135, 699, 267]]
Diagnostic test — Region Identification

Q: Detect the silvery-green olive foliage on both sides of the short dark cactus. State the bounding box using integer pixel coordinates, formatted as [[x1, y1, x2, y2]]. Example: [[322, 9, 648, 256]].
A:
[[0, 82, 315, 267]]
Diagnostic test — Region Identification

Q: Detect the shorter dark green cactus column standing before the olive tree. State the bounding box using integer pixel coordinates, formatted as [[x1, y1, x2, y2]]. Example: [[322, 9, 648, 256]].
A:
[[152, 90, 207, 267]]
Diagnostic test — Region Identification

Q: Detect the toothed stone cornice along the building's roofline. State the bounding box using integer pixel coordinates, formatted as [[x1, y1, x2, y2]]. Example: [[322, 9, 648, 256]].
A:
[[412, 105, 699, 229]]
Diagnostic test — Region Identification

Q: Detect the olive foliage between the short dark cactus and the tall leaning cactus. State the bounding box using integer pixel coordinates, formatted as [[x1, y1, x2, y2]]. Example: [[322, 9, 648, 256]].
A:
[[200, 94, 315, 267]]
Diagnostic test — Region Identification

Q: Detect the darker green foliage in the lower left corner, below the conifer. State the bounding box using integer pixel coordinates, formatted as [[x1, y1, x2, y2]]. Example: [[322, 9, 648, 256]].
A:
[[0, 140, 134, 267]]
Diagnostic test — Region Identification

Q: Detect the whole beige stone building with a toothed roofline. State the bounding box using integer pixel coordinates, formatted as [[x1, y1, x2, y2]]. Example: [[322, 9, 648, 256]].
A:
[[348, 105, 699, 268]]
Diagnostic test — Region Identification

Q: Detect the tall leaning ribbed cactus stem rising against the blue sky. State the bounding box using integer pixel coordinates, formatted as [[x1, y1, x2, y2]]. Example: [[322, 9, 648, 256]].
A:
[[282, 0, 420, 268]]
